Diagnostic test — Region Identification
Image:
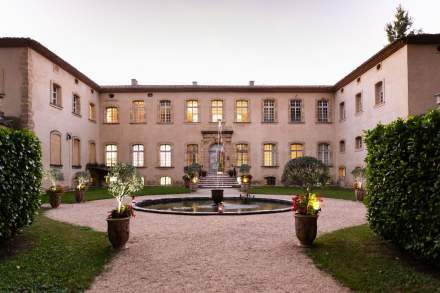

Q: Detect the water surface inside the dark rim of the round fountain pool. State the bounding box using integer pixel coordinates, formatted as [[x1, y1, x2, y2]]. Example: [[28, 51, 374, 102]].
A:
[[134, 197, 292, 216]]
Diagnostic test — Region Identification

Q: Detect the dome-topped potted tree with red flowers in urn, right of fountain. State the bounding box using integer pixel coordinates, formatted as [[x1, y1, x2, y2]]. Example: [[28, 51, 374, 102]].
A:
[[281, 156, 330, 246]]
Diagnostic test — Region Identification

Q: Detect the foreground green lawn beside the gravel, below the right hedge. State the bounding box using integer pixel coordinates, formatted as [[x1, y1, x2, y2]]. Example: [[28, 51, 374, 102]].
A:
[[307, 225, 440, 292]]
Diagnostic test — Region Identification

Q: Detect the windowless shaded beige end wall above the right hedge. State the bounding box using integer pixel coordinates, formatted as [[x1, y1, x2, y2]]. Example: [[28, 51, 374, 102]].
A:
[[408, 45, 440, 115]]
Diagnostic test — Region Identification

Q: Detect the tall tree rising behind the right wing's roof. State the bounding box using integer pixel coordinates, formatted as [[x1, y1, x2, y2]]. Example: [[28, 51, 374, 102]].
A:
[[385, 4, 422, 43]]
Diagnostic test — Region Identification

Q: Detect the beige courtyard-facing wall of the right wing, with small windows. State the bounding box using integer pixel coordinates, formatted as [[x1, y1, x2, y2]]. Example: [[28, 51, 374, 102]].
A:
[[335, 46, 408, 184]]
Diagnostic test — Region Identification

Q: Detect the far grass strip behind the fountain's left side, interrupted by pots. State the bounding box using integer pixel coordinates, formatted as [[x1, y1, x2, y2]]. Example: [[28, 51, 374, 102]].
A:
[[41, 186, 189, 203]]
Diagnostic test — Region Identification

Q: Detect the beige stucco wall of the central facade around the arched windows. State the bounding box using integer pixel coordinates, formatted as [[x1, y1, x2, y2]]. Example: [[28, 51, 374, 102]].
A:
[[100, 92, 334, 184]]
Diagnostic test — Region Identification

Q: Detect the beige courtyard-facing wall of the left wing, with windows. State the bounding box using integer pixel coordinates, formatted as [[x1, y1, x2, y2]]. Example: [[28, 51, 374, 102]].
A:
[[29, 49, 100, 185]]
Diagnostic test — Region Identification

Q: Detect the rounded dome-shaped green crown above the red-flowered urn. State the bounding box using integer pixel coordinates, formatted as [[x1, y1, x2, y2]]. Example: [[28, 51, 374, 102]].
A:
[[281, 156, 330, 192]]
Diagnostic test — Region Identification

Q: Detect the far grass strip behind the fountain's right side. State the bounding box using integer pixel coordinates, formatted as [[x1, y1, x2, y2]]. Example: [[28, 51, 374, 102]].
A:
[[250, 186, 356, 200]]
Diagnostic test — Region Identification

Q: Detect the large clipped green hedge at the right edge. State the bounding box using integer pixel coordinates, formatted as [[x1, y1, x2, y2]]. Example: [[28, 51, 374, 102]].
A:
[[366, 111, 440, 262]]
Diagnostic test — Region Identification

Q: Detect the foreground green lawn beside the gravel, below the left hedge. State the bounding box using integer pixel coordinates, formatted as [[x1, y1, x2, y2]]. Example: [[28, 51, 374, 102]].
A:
[[0, 215, 114, 292]]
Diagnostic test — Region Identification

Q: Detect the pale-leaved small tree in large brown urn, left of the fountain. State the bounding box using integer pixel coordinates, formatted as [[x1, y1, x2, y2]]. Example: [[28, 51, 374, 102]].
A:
[[107, 163, 143, 249]]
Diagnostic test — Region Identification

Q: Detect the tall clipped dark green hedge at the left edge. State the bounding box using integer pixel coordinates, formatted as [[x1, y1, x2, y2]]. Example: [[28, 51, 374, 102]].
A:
[[0, 128, 42, 241]]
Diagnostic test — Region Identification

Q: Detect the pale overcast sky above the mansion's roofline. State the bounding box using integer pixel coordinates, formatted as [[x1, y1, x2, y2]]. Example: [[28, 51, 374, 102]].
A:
[[0, 0, 440, 85]]
